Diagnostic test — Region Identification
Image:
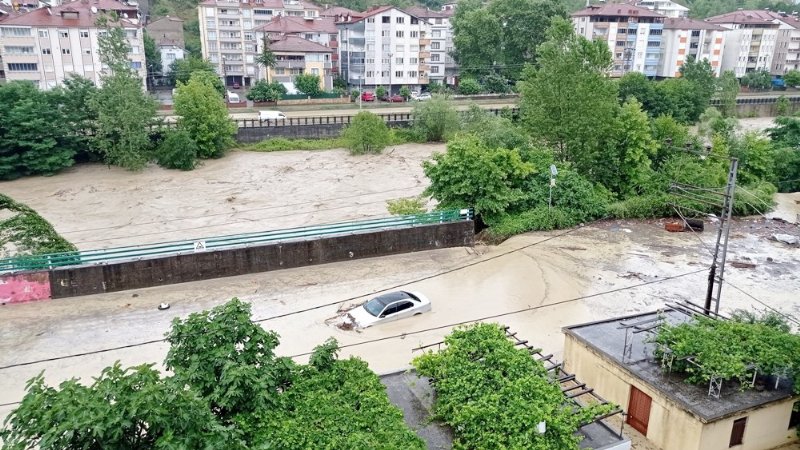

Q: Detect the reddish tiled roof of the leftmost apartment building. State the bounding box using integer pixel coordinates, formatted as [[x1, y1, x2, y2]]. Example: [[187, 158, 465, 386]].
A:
[[3, 0, 141, 28]]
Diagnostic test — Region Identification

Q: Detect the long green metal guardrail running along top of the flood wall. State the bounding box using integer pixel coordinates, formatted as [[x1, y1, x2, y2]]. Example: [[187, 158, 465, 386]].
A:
[[0, 209, 473, 273]]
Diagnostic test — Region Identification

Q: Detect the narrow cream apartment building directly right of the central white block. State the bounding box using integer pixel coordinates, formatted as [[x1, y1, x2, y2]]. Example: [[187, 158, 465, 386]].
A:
[[404, 6, 458, 84]]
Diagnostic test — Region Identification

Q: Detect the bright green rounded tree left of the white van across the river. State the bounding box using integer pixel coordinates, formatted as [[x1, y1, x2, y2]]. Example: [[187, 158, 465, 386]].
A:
[[175, 72, 236, 159]]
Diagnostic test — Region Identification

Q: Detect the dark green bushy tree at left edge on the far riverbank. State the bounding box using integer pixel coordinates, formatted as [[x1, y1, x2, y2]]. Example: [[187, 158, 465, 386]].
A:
[[0, 82, 83, 180]]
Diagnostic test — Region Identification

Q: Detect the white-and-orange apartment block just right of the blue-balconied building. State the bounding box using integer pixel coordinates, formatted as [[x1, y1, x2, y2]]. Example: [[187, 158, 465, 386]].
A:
[[658, 17, 726, 77]]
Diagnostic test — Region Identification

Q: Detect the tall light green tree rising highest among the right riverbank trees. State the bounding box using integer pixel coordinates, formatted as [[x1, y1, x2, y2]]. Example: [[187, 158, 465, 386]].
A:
[[520, 19, 619, 174]]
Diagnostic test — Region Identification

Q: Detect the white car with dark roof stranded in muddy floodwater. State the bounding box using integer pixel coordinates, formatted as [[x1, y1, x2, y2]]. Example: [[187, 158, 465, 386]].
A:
[[348, 291, 431, 328]]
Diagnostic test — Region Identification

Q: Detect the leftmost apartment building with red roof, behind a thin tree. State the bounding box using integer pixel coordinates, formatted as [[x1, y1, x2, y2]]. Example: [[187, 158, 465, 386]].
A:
[[0, 0, 147, 89]]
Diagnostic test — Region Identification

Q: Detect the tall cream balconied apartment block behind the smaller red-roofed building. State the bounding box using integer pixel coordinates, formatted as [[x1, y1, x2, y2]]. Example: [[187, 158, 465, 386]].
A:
[[197, 0, 321, 86]]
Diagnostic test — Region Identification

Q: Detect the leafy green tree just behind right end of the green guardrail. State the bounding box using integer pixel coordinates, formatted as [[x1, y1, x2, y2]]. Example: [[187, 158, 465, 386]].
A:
[[422, 136, 533, 221]]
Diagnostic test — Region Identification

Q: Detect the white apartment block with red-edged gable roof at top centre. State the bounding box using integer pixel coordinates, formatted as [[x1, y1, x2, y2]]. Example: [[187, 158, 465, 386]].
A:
[[336, 6, 432, 92]]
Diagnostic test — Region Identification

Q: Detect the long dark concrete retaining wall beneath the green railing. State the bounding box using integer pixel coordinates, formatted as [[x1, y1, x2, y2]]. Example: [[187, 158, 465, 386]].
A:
[[36, 220, 475, 302]]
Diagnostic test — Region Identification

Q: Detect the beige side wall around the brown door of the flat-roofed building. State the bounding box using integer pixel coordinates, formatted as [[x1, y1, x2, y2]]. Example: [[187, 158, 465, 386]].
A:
[[564, 335, 704, 450]]
